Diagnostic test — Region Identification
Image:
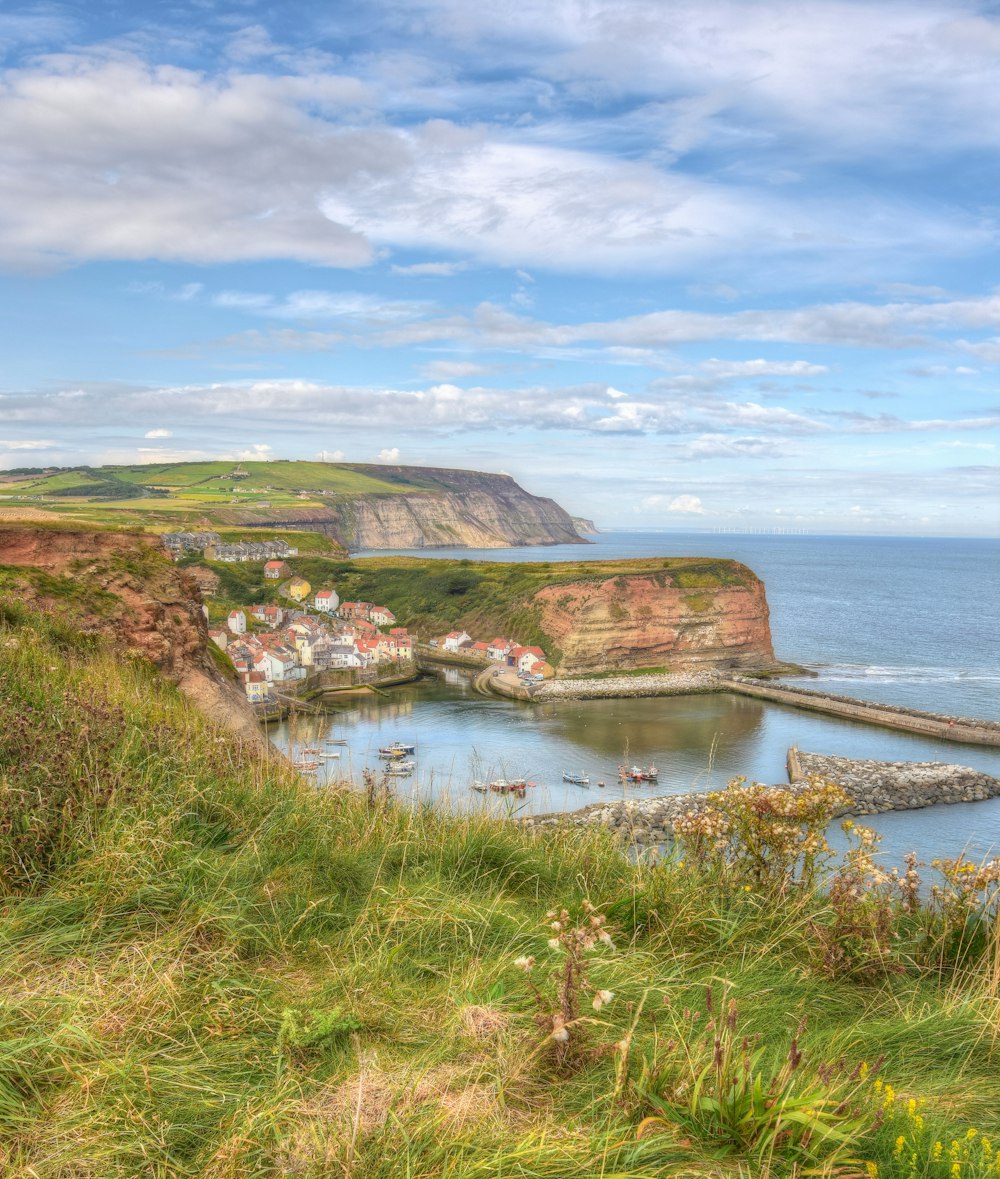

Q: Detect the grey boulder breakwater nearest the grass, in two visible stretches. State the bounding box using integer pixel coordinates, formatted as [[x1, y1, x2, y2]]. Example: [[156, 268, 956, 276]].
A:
[[522, 750, 1000, 845]]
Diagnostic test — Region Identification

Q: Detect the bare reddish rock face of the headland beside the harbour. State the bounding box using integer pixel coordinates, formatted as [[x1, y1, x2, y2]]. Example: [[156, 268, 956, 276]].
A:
[[534, 561, 775, 676]]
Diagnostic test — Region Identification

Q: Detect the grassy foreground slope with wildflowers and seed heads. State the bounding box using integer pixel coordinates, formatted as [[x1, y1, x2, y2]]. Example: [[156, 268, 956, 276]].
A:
[[0, 602, 1000, 1179]]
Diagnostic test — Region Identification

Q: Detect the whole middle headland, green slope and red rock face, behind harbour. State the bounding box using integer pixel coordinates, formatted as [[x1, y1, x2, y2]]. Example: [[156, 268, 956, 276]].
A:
[[338, 558, 775, 676]]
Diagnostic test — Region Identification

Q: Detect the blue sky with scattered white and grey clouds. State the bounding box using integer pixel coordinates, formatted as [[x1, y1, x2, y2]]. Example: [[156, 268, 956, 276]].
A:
[[0, 0, 1000, 536]]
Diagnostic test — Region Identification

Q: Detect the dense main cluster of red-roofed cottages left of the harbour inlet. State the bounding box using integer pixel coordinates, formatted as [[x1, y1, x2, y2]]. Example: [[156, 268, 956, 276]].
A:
[[209, 591, 414, 704]]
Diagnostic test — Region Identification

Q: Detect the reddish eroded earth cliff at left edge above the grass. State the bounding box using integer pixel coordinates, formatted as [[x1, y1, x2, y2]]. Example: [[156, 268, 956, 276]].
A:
[[0, 525, 264, 744]]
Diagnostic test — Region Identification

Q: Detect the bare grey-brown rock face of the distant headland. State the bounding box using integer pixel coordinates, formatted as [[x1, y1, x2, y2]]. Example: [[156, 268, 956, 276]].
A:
[[226, 467, 586, 552]]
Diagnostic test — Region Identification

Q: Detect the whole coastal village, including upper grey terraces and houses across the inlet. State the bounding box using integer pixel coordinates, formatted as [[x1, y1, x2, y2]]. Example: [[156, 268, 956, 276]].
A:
[[189, 534, 554, 706]]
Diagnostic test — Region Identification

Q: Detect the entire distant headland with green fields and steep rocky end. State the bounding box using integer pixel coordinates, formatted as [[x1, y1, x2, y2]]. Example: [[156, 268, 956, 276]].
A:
[[0, 461, 586, 552]]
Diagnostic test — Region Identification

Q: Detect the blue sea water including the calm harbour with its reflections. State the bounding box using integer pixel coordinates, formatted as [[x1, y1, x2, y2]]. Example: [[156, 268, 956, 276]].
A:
[[271, 531, 1000, 863]]
